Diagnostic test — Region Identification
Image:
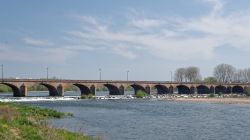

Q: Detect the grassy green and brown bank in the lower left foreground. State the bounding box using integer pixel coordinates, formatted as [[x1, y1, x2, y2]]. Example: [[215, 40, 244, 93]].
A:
[[0, 102, 92, 140]]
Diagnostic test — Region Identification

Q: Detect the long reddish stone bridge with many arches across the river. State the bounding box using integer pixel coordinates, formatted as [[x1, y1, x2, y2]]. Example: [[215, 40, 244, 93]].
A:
[[0, 79, 250, 97]]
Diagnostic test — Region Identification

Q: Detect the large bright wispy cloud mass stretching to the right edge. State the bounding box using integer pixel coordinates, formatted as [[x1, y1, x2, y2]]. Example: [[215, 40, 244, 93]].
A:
[[65, 0, 250, 60]]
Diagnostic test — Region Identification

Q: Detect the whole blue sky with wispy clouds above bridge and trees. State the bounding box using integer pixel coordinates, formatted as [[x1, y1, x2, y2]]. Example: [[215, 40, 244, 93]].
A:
[[0, 0, 250, 81]]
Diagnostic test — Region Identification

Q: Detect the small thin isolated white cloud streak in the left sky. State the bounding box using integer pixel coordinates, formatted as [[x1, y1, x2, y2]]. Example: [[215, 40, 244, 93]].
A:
[[23, 37, 53, 46]]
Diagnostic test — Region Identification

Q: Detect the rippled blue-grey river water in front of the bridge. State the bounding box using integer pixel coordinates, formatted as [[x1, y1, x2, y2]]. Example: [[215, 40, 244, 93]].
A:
[[1, 92, 250, 140]]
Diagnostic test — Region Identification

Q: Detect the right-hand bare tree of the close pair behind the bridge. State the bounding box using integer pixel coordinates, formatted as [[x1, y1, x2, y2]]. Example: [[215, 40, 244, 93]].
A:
[[185, 66, 201, 82]]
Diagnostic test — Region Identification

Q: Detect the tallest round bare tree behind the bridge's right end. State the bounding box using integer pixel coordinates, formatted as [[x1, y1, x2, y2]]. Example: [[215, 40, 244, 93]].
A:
[[214, 64, 236, 83]]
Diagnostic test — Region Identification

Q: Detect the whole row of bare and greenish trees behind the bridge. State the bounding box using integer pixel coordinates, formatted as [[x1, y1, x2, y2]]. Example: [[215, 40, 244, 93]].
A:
[[174, 64, 250, 83]]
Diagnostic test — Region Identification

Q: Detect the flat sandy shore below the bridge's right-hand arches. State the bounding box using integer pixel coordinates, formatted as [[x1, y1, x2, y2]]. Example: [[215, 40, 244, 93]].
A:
[[173, 98, 250, 104]]
